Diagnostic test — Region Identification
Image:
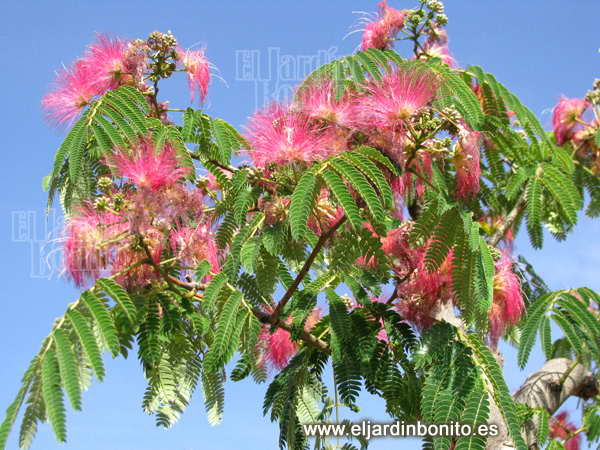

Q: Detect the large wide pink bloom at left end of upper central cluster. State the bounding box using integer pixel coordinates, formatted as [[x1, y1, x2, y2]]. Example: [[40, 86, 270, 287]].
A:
[[246, 103, 346, 167]]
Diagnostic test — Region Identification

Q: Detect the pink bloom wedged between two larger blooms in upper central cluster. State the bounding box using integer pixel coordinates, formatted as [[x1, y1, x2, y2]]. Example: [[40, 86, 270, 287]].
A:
[[295, 80, 353, 126]]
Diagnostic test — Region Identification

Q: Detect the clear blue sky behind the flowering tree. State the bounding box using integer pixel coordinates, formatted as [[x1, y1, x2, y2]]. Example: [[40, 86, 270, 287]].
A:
[[0, 0, 600, 450]]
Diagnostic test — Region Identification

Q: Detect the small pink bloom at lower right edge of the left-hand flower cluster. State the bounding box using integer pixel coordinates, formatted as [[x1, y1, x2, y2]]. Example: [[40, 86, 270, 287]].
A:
[[169, 224, 219, 273]]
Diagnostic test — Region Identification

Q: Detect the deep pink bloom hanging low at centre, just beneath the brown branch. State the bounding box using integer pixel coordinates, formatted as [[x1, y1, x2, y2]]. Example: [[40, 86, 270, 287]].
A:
[[259, 308, 321, 370]]
